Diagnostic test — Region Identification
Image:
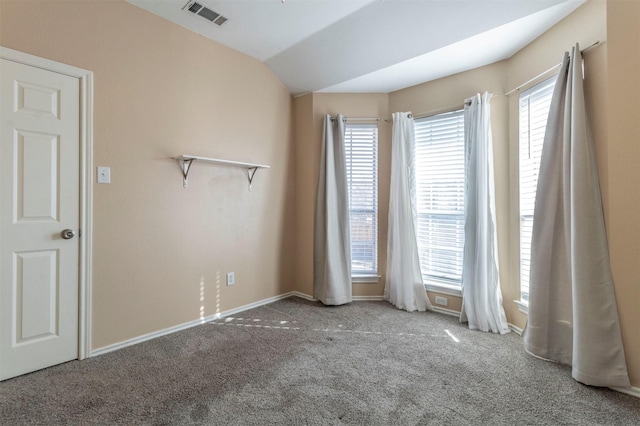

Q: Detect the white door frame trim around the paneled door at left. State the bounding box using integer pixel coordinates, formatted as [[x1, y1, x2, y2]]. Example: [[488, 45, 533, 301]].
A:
[[0, 46, 93, 360]]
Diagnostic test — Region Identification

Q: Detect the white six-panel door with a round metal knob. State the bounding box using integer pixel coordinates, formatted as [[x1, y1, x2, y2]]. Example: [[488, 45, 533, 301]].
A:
[[0, 59, 80, 380]]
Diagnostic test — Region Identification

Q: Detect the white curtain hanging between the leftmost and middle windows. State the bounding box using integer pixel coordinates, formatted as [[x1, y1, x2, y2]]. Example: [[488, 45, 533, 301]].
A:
[[384, 112, 433, 312]]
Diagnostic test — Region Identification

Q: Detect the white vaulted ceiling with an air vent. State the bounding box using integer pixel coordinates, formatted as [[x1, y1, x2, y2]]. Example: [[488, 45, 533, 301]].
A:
[[128, 0, 586, 95]]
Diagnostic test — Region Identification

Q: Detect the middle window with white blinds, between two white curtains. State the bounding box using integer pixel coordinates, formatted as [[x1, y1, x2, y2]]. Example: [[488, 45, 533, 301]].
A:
[[415, 110, 465, 289]]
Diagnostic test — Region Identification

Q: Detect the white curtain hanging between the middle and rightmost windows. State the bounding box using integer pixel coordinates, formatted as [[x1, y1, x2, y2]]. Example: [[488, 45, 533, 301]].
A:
[[460, 93, 509, 334]]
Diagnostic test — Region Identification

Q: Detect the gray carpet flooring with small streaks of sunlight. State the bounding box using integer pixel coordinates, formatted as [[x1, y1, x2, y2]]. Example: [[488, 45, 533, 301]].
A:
[[0, 298, 640, 425]]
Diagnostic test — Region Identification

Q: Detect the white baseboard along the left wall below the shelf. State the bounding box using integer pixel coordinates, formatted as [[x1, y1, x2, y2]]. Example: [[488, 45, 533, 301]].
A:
[[89, 291, 298, 357]]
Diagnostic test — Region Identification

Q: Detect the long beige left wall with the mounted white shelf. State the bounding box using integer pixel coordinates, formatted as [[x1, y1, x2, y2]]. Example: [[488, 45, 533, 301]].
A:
[[0, 0, 295, 348]]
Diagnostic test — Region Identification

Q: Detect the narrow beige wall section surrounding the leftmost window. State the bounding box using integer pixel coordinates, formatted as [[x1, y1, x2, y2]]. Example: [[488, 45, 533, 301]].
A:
[[294, 93, 391, 296]]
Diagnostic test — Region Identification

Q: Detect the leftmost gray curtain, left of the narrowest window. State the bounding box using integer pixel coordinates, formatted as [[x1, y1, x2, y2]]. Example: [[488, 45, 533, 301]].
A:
[[313, 115, 352, 305]]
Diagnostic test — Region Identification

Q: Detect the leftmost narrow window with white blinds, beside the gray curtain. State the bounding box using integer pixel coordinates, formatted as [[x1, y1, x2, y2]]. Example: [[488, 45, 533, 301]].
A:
[[345, 123, 378, 276]]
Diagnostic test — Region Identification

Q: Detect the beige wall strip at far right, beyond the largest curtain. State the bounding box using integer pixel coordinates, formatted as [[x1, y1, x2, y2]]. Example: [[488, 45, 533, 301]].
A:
[[600, 1, 640, 387]]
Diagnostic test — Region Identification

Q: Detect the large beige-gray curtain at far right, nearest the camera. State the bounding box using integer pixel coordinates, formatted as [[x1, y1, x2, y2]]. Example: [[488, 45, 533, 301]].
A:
[[524, 45, 629, 386]]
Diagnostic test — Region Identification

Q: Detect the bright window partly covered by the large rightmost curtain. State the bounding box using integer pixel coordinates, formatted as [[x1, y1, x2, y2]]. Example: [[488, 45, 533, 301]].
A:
[[519, 77, 556, 304]]
